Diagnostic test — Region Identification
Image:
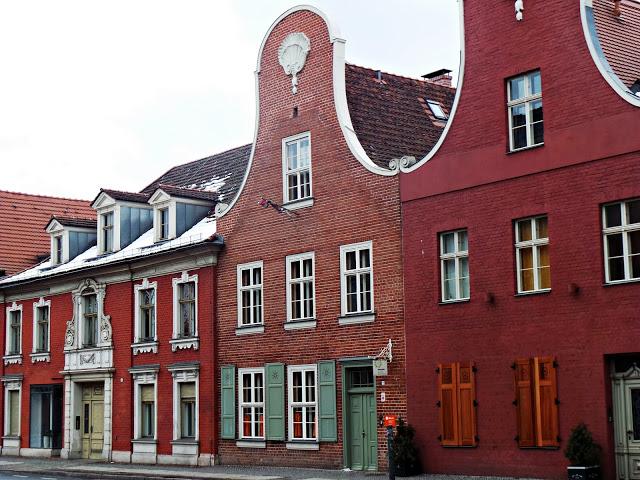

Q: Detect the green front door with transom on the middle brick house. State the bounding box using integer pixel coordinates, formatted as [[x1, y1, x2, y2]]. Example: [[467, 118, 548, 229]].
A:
[[345, 367, 378, 470]]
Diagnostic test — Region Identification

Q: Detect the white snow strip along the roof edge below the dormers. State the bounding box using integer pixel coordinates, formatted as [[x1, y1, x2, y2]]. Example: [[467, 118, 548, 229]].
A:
[[0, 217, 216, 287]]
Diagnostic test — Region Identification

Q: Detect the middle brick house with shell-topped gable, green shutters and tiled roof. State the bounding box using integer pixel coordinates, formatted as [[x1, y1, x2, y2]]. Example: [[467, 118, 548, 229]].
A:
[[216, 7, 454, 470]]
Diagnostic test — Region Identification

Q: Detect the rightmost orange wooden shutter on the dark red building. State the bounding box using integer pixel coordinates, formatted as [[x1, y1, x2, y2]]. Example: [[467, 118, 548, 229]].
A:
[[533, 357, 559, 447]]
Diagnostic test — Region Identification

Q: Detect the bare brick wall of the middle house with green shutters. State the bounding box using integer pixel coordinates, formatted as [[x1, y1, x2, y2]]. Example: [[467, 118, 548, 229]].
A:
[[217, 11, 405, 468]]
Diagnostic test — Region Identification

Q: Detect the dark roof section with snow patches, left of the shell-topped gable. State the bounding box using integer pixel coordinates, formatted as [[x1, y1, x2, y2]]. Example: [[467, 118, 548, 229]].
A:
[[142, 145, 251, 202]]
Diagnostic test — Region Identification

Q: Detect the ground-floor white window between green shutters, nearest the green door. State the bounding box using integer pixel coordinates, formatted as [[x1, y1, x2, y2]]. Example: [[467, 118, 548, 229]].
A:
[[289, 365, 318, 440]]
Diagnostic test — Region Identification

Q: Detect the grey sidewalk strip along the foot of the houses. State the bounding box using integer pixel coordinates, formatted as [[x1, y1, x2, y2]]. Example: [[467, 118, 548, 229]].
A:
[[0, 456, 524, 480]]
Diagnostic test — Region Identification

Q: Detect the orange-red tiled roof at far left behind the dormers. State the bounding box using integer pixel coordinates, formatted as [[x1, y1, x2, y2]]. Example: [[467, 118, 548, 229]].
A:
[[0, 190, 95, 275]]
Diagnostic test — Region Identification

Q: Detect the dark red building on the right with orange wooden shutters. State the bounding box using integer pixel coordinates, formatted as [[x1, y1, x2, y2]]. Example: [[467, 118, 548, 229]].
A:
[[401, 0, 640, 479]]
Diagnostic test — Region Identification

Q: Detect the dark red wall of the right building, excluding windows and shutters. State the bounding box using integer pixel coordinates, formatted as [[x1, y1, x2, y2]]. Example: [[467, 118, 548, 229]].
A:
[[401, 0, 640, 478]]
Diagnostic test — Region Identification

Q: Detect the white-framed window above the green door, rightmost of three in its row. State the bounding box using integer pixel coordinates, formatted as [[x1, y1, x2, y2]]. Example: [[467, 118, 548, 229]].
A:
[[340, 242, 373, 315]]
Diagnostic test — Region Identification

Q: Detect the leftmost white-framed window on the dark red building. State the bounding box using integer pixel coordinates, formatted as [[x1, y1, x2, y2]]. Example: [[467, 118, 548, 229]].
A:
[[440, 230, 469, 302]]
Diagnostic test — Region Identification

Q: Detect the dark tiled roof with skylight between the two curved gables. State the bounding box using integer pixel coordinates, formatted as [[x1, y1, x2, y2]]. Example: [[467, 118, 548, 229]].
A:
[[345, 64, 456, 168]]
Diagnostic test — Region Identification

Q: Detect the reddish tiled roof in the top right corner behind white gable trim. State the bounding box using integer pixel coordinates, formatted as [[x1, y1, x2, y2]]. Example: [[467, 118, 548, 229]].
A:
[[593, 0, 640, 88]]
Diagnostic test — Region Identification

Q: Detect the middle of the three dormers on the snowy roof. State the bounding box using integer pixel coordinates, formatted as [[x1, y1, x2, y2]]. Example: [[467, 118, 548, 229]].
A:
[[91, 189, 153, 254]]
